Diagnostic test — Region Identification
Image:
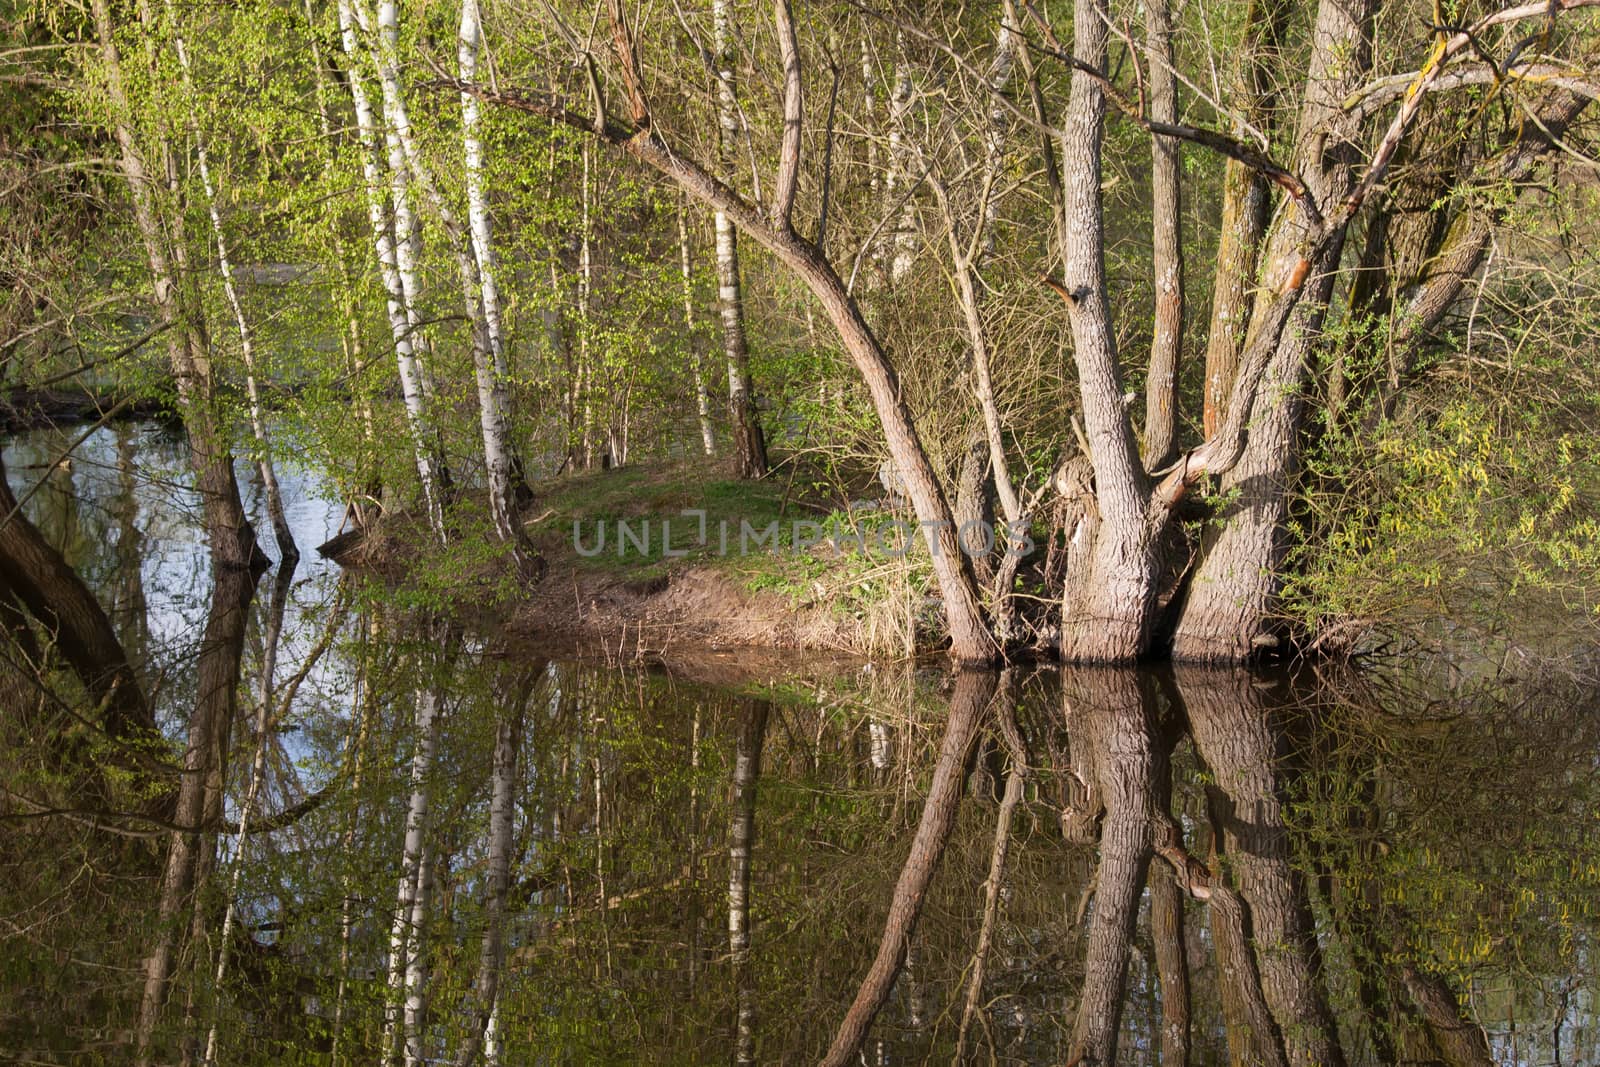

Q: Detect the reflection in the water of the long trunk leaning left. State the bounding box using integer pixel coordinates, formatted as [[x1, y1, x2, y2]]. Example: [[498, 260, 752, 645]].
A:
[[822, 670, 995, 1067]]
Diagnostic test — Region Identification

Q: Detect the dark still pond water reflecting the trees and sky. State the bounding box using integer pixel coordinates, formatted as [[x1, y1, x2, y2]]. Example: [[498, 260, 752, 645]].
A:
[[0, 427, 1600, 1065]]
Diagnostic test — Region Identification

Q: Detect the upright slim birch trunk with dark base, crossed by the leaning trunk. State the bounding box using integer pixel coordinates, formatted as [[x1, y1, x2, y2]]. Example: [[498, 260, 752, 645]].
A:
[[712, 0, 766, 478]]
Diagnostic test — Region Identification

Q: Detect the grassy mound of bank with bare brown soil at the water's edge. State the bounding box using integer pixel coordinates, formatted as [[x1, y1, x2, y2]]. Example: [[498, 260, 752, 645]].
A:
[[328, 461, 939, 677]]
